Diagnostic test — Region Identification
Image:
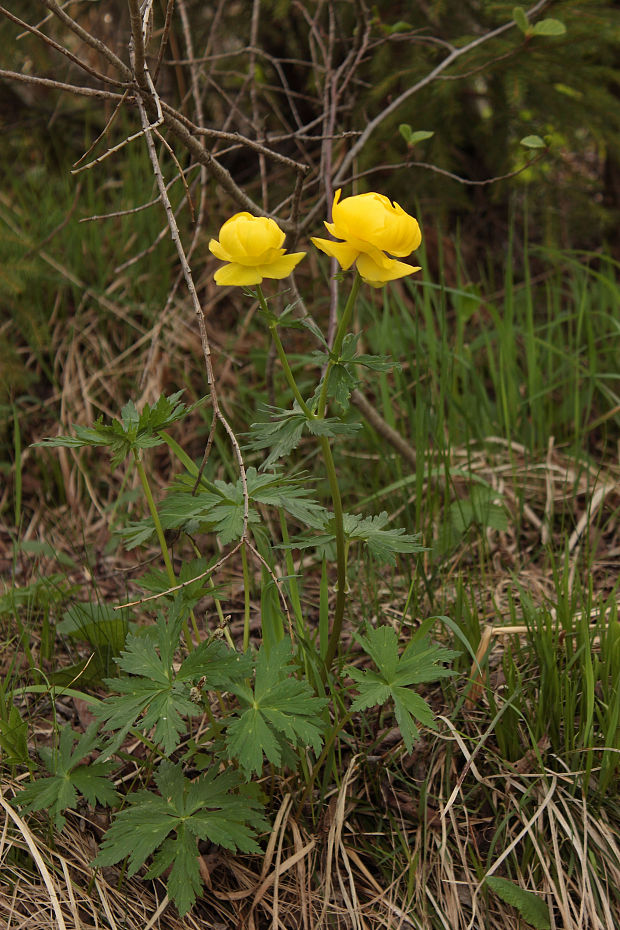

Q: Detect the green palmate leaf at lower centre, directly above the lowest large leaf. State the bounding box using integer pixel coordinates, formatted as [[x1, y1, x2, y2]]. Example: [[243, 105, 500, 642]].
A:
[[226, 638, 327, 777]]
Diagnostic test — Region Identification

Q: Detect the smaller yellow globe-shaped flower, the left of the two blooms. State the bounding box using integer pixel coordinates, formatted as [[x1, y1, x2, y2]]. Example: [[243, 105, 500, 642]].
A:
[[209, 213, 306, 285]]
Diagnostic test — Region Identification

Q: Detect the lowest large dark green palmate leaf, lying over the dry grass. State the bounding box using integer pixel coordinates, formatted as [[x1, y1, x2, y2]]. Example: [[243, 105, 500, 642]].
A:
[[93, 761, 268, 915]]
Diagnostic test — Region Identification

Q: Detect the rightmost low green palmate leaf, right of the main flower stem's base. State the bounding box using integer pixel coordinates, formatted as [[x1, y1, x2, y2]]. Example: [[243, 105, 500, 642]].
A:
[[348, 626, 458, 752]]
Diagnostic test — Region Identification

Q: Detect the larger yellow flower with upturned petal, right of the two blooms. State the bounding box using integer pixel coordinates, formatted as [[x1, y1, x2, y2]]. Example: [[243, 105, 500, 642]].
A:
[[312, 190, 422, 287]]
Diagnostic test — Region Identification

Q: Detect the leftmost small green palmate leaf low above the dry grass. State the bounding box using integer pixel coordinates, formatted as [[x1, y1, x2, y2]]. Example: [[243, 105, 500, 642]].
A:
[[16, 724, 118, 831]]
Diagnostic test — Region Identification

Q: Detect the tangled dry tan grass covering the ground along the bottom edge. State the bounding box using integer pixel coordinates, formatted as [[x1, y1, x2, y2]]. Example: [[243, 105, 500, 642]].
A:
[[0, 721, 620, 930]]
